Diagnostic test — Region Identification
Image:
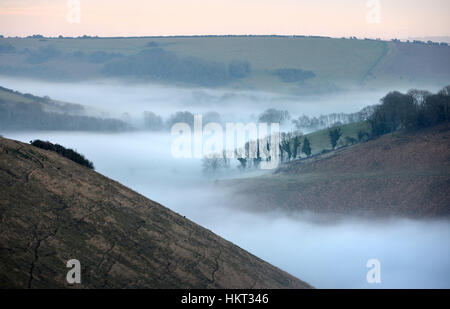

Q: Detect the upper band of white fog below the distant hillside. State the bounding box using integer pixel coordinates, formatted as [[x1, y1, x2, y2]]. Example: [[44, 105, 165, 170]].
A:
[[0, 76, 430, 121]]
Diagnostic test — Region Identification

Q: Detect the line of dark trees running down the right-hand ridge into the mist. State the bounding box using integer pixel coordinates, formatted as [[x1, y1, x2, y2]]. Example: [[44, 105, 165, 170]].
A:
[[203, 86, 450, 173]]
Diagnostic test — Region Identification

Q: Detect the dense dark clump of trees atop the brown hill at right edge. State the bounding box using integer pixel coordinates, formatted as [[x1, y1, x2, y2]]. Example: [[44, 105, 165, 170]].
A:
[[368, 86, 450, 137]]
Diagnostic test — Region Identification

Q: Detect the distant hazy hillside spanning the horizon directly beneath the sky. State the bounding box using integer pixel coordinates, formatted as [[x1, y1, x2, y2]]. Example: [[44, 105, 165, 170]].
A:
[[0, 36, 450, 94]]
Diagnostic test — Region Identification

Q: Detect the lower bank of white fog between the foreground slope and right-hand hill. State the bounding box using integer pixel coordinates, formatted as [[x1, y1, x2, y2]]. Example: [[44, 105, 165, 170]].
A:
[[5, 132, 450, 288]]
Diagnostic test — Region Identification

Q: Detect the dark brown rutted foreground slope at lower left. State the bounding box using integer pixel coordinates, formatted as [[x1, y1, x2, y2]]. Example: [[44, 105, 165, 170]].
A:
[[0, 138, 309, 288]]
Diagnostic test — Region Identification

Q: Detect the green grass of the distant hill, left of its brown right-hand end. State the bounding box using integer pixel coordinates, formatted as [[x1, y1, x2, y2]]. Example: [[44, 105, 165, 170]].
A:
[[0, 36, 387, 92]]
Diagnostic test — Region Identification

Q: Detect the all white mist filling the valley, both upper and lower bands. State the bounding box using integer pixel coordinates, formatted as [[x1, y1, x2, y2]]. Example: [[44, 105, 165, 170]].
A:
[[0, 78, 450, 288]]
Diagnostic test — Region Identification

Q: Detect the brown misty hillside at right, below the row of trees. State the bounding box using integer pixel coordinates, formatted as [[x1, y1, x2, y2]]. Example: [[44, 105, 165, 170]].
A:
[[227, 124, 450, 218]]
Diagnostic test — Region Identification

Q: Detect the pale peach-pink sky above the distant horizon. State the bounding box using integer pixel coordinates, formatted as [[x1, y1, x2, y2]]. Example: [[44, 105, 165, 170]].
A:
[[0, 0, 450, 39]]
